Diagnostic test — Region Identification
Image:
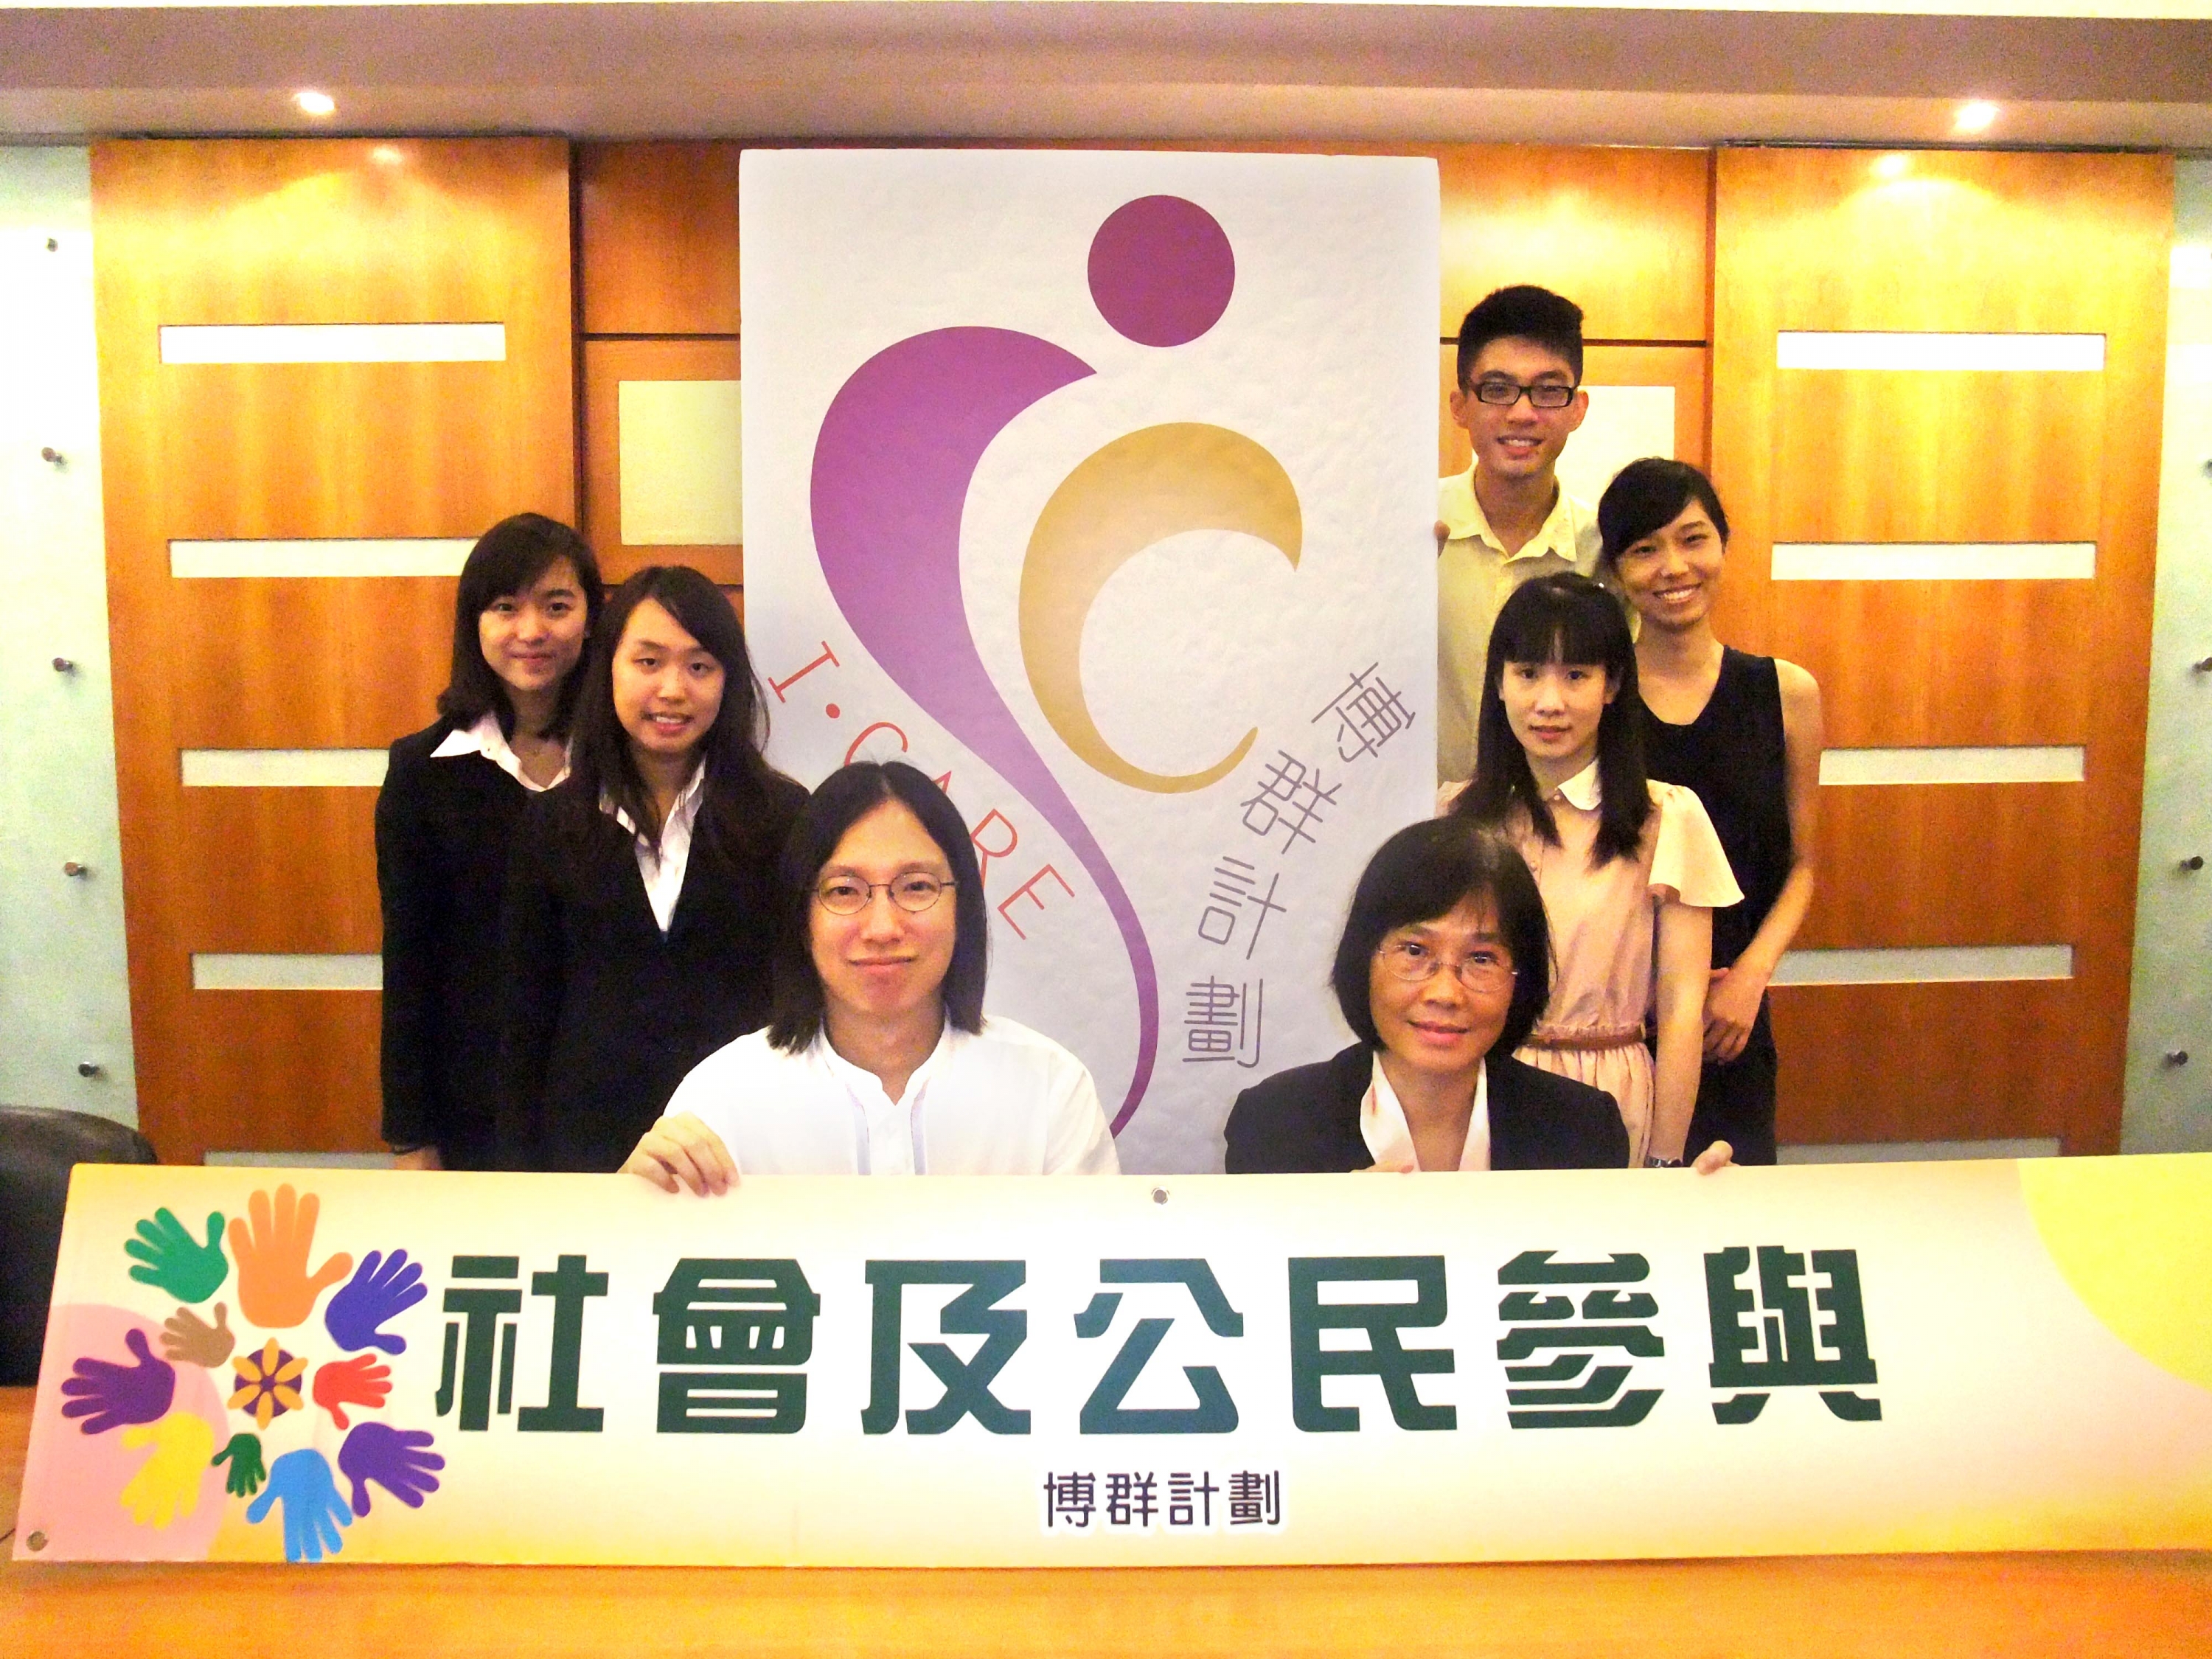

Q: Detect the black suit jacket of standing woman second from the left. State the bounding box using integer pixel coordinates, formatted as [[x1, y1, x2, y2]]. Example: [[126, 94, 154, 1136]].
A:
[[498, 779, 805, 1170]]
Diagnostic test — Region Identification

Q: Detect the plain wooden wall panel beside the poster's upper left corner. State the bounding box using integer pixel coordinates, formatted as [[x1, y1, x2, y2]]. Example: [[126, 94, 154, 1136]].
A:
[[575, 144, 739, 334]]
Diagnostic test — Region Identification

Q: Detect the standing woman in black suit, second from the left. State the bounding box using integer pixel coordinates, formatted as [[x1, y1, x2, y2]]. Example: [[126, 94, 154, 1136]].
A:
[[498, 564, 805, 1170]]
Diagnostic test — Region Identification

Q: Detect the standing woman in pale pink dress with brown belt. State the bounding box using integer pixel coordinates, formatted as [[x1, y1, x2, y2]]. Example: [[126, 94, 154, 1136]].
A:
[[1451, 575, 1743, 1168]]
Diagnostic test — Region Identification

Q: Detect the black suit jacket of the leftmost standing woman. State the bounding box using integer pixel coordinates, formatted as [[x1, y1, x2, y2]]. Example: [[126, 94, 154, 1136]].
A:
[[376, 719, 529, 1170]]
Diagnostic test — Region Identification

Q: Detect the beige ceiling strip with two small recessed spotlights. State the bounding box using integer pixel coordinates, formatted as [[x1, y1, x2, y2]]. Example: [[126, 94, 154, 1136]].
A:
[[0, 0, 2212, 150]]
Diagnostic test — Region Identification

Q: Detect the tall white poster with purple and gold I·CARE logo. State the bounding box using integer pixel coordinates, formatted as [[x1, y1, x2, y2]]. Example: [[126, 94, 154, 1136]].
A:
[[741, 150, 1438, 1172]]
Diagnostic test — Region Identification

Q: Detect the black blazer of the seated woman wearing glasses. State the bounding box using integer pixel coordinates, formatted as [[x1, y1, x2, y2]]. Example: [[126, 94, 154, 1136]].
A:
[[1228, 1042, 1628, 1175]]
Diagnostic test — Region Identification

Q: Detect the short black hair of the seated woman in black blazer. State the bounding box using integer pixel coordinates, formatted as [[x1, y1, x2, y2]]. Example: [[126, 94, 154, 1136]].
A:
[[1329, 816, 1551, 1053]]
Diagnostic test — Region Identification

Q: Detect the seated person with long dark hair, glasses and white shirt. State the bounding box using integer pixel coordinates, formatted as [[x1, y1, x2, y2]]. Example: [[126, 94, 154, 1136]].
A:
[[622, 761, 1119, 1192]]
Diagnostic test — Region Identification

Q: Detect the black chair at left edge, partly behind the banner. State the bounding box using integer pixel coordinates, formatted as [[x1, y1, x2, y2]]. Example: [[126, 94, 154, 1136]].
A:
[[0, 1106, 161, 1387]]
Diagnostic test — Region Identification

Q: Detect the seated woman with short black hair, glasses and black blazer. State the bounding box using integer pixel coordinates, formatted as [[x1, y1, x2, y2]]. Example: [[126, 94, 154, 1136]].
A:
[[1225, 818, 1728, 1175]]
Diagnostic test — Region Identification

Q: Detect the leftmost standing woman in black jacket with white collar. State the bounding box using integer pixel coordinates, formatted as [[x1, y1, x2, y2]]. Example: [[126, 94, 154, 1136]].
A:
[[376, 513, 599, 1170]]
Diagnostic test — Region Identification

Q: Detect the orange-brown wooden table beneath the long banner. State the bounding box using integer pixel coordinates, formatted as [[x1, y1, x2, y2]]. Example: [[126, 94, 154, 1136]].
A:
[[0, 1389, 2212, 1659]]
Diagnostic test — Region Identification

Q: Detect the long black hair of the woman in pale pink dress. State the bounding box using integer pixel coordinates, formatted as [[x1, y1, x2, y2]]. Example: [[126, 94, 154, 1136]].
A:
[[1451, 571, 1655, 869]]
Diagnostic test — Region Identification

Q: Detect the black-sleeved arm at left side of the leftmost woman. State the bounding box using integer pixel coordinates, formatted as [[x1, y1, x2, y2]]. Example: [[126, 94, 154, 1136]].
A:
[[376, 745, 440, 1168]]
